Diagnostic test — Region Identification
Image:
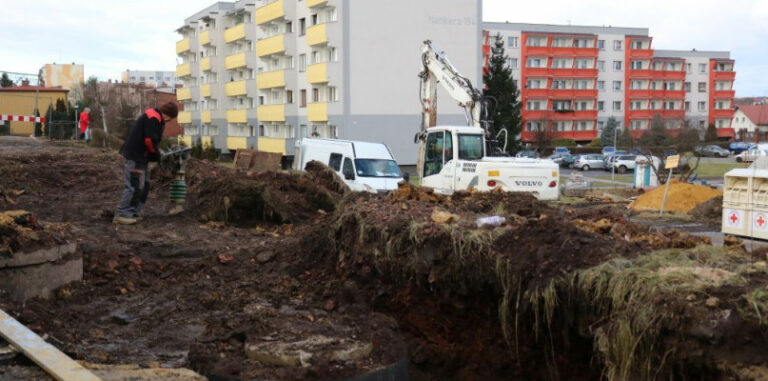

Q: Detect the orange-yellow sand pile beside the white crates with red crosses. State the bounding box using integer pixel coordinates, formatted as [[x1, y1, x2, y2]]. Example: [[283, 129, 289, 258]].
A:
[[629, 181, 723, 213]]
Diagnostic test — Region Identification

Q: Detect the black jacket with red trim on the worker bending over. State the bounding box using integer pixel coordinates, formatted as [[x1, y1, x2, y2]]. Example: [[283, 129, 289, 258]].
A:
[[120, 108, 165, 166]]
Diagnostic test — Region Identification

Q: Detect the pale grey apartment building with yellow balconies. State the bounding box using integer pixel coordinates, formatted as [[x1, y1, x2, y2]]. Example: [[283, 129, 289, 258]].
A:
[[176, 0, 482, 165]]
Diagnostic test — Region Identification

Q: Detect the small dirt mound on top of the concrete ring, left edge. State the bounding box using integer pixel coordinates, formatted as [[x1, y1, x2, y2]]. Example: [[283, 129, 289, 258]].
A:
[[0, 210, 66, 258]]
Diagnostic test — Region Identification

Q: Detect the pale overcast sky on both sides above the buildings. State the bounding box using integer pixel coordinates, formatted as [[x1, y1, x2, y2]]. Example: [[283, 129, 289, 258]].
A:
[[0, 0, 768, 97]]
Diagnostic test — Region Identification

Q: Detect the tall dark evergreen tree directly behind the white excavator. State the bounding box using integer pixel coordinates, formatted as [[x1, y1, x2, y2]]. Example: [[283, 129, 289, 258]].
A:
[[483, 34, 522, 154]]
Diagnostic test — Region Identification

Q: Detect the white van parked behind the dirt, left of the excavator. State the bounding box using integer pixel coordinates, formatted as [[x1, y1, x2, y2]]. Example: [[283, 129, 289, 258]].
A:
[[293, 139, 403, 193]]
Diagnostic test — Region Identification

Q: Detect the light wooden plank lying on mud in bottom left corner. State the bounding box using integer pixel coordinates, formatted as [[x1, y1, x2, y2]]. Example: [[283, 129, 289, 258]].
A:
[[0, 310, 101, 381]]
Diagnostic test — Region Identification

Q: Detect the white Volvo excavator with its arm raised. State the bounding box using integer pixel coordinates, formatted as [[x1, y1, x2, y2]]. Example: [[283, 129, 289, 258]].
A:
[[414, 40, 560, 200]]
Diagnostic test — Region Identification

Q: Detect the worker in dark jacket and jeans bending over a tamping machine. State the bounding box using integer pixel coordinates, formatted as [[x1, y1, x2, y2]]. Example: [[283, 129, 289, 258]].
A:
[[112, 102, 179, 225]]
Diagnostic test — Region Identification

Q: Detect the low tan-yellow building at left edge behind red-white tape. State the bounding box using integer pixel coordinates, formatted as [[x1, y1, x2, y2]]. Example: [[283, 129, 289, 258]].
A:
[[0, 84, 69, 136]]
